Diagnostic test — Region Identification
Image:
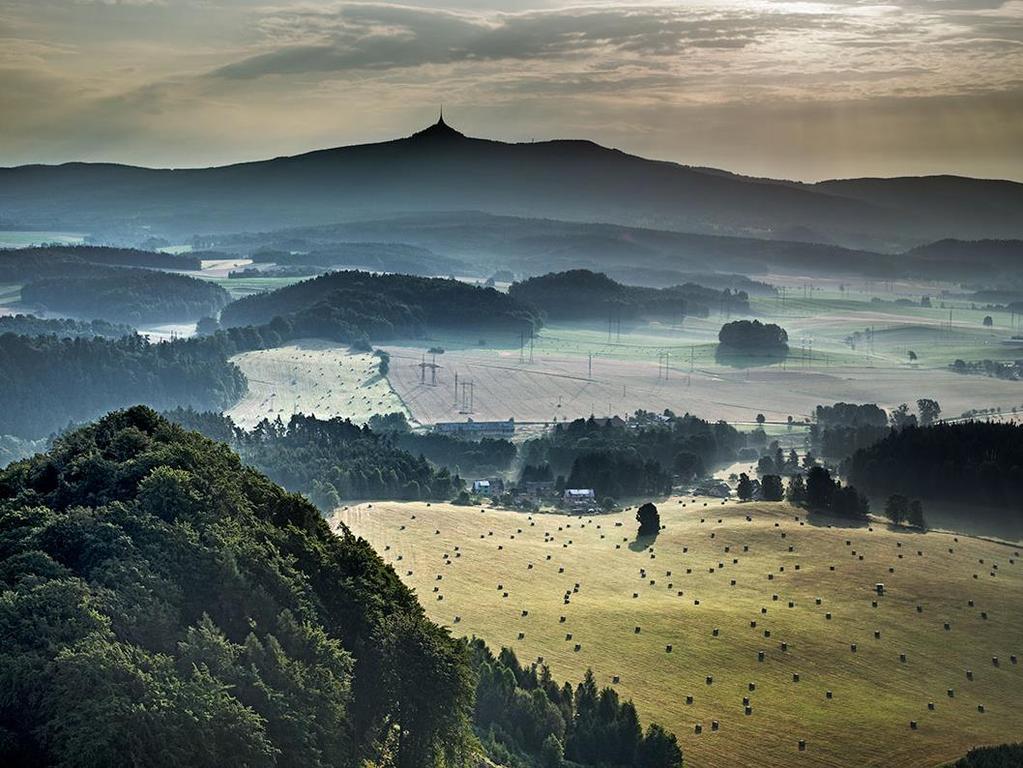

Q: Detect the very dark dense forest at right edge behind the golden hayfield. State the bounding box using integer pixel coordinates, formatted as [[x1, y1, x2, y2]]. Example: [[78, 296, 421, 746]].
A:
[[846, 421, 1023, 513]]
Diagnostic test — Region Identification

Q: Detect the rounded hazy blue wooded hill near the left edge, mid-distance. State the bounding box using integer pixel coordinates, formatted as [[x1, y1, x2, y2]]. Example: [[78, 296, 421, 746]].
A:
[[21, 268, 230, 324]]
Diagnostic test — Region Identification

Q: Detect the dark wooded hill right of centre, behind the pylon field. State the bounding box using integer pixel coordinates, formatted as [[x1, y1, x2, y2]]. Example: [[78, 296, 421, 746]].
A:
[[508, 269, 750, 322]]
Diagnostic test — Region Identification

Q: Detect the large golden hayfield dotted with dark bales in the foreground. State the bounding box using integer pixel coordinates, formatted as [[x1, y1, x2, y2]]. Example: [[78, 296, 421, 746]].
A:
[[332, 499, 1023, 768]]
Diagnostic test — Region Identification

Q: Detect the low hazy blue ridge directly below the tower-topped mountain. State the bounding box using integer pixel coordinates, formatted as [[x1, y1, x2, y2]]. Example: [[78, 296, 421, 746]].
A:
[[201, 211, 902, 280]]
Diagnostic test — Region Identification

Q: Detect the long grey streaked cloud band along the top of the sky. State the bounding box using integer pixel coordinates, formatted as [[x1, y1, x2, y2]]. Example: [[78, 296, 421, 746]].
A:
[[215, 4, 843, 79]]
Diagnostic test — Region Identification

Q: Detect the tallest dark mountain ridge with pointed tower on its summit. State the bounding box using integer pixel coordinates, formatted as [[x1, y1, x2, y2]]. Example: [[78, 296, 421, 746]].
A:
[[0, 121, 1023, 251]]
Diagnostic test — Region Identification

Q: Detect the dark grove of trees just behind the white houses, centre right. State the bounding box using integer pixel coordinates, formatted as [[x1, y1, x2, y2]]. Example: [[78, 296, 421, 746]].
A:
[[522, 411, 746, 498]]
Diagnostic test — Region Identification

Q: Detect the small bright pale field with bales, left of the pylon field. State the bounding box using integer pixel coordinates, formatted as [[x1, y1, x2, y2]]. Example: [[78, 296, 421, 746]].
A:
[[225, 340, 407, 427]]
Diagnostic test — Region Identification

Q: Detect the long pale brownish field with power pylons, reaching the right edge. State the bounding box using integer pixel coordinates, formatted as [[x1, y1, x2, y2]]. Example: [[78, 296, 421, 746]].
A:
[[385, 333, 1023, 423]]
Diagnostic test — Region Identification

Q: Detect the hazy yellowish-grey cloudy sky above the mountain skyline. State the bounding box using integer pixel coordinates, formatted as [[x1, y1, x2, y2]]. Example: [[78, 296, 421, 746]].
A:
[[0, 0, 1023, 181]]
